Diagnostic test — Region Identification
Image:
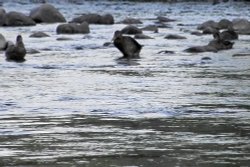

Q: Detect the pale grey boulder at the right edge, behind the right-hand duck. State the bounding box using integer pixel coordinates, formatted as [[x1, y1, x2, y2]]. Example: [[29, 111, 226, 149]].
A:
[[233, 19, 250, 34]]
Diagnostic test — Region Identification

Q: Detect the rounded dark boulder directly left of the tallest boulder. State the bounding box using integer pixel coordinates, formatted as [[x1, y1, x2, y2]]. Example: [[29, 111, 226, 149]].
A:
[[3, 12, 36, 26]]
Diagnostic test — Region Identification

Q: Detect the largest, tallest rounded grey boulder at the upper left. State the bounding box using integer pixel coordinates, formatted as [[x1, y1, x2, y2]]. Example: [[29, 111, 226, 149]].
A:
[[30, 4, 66, 23]]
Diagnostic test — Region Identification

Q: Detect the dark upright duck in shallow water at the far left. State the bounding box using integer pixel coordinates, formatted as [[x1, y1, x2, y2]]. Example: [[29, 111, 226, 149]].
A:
[[5, 35, 26, 62]]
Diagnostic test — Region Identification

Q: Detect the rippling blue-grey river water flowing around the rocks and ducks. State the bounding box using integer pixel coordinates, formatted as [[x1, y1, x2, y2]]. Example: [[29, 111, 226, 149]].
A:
[[0, 1, 250, 167]]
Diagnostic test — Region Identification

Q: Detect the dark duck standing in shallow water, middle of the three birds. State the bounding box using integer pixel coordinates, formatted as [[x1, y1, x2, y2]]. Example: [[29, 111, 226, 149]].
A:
[[113, 31, 142, 59]]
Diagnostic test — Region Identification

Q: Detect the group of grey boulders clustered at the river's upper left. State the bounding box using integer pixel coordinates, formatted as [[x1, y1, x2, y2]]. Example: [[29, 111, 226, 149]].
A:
[[0, 3, 114, 34]]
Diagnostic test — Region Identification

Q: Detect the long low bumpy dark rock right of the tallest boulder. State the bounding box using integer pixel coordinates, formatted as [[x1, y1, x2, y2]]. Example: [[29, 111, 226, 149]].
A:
[[71, 13, 114, 24]]
